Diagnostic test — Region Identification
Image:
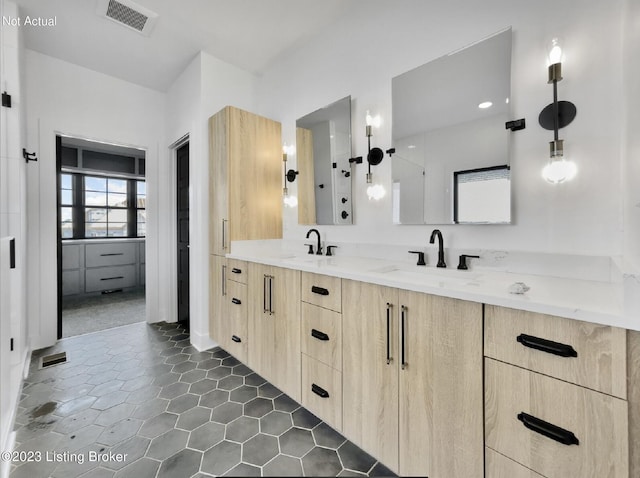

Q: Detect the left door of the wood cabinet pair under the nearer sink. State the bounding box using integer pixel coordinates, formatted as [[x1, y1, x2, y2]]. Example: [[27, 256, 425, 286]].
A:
[[342, 279, 400, 471]]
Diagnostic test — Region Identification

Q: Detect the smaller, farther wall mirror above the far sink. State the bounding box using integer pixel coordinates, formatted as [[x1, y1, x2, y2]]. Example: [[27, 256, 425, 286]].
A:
[[296, 96, 353, 224]]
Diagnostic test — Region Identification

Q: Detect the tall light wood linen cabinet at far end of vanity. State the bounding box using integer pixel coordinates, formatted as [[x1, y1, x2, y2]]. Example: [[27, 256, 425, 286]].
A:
[[209, 106, 282, 350]]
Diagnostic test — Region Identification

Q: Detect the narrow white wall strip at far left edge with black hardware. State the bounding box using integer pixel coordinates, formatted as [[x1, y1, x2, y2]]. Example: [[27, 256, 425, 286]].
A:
[[0, 0, 29, 470]]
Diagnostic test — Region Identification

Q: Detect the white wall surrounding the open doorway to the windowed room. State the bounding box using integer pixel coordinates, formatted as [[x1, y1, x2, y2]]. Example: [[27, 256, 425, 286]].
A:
[[25, 50, 168, 349]]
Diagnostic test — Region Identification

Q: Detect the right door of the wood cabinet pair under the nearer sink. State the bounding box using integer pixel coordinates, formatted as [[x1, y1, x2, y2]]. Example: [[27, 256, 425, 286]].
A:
[[398, 290, 484, 478]]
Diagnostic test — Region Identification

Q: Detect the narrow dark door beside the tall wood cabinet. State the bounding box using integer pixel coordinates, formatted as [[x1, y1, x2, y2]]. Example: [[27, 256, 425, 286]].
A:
[[177, 143, 189, 328]]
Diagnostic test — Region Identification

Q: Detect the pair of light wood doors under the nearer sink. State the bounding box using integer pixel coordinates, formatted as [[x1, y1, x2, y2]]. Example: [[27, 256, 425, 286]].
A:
[[342, 280, 484, 478]]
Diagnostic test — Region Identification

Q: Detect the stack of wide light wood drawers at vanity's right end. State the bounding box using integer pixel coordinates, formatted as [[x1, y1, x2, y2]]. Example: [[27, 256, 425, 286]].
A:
[[485, 306, 637, 478]]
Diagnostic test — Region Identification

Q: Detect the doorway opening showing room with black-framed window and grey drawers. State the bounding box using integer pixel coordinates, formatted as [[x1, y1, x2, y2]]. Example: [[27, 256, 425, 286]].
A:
[[56, 136, 146, 339]]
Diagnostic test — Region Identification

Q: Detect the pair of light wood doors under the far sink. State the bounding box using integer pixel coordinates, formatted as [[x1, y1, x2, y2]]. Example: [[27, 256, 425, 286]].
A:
[[247, 264, 301, 401]]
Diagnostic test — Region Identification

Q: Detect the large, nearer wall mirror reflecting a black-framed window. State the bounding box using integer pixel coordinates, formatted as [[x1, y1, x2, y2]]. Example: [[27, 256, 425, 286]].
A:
[[392, 28, 511, 224]]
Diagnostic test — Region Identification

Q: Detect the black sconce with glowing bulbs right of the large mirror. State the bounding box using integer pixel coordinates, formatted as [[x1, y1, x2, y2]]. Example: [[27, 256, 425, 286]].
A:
[[538, 38, 577, 184]]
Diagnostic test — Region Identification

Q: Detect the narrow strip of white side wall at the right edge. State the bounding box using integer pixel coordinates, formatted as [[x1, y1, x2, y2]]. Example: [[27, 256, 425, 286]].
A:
[[623, 0, 640, 270]]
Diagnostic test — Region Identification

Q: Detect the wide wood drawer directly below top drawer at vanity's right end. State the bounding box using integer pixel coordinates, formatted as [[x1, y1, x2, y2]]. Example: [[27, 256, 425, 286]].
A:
[[485, 359, 629, 478]]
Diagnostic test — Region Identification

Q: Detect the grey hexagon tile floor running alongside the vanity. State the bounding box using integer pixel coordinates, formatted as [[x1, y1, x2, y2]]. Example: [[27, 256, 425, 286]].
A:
[[10, 323, 394, 478]]
